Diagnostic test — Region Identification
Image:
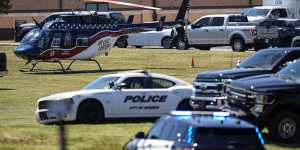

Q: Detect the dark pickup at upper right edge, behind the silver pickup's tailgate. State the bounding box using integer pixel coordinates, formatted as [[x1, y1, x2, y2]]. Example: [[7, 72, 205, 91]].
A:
[[254, 19, 300, 51]]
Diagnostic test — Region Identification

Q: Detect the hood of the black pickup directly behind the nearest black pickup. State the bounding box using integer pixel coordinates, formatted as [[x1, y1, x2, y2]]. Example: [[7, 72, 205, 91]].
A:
[[197, 68, 271, 79]]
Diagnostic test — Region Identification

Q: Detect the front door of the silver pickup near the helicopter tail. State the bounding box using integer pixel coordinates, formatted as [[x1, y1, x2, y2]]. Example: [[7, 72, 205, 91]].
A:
[[206, 17, 225, 44]]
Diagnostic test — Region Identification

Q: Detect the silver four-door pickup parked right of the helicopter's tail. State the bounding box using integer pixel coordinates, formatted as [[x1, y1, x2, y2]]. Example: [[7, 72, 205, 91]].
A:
[[175, 15, 256, 51]]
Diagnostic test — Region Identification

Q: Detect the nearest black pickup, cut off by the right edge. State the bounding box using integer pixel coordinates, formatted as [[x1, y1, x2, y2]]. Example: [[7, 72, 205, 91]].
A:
[[225, 56, 300, 143]]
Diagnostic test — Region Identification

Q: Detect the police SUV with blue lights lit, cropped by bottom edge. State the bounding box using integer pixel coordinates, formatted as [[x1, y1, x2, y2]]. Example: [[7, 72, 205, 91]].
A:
[[124, 112, 265, 150]]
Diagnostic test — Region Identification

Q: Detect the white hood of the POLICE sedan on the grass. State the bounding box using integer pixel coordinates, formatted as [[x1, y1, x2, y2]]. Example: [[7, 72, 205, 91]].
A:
[[39, 89, 112, 101]]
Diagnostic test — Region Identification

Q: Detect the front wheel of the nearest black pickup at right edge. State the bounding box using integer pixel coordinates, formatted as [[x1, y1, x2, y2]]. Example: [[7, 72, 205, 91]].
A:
[[268, 112, 300, 143]]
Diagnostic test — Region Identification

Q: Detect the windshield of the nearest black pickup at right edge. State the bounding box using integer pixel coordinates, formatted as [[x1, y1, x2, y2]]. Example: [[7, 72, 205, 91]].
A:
[[275, 60, 300, 83]]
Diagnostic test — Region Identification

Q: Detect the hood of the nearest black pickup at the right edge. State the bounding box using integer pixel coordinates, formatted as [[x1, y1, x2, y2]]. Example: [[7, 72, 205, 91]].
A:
[[231, 74, 300, 94]]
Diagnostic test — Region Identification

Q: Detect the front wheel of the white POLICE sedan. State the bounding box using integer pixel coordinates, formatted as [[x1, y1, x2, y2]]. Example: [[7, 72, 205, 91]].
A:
[[76, 100, 104, 124]]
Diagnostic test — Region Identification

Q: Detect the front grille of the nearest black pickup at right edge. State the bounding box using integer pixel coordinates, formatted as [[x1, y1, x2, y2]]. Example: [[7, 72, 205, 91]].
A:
[[226, 87, 256, 109]]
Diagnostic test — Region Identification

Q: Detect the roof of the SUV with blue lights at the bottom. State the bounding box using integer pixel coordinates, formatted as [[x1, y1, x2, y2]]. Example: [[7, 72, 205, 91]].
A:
[[166, 114, 256, 129]]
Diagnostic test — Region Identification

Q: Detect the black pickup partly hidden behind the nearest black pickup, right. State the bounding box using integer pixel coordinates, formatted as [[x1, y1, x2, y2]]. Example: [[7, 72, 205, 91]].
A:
[[191, 48, 300, 110]]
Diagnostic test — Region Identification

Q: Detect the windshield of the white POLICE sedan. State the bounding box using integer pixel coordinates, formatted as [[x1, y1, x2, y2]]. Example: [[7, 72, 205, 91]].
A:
[[83, 77, 120, 90]]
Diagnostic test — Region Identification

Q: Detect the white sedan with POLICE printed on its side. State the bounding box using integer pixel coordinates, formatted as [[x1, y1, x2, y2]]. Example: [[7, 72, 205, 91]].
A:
[[36, 71, 193, 123]]
